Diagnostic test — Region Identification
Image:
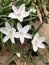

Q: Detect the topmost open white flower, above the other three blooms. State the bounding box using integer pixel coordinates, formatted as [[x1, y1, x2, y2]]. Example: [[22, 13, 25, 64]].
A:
[[8, 4, 29, 22]]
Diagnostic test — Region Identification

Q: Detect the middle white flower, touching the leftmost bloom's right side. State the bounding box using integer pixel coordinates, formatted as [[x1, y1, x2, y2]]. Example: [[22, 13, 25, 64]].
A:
[[16, 23, 32, 44]]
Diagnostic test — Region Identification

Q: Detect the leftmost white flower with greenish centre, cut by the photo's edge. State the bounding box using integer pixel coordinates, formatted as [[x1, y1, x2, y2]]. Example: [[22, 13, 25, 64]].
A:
[[0, 22, 16, 43]]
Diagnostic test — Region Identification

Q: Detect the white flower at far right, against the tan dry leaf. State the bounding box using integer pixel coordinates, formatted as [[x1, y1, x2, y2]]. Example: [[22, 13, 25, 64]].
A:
[[31, 33, 45, 52]]
